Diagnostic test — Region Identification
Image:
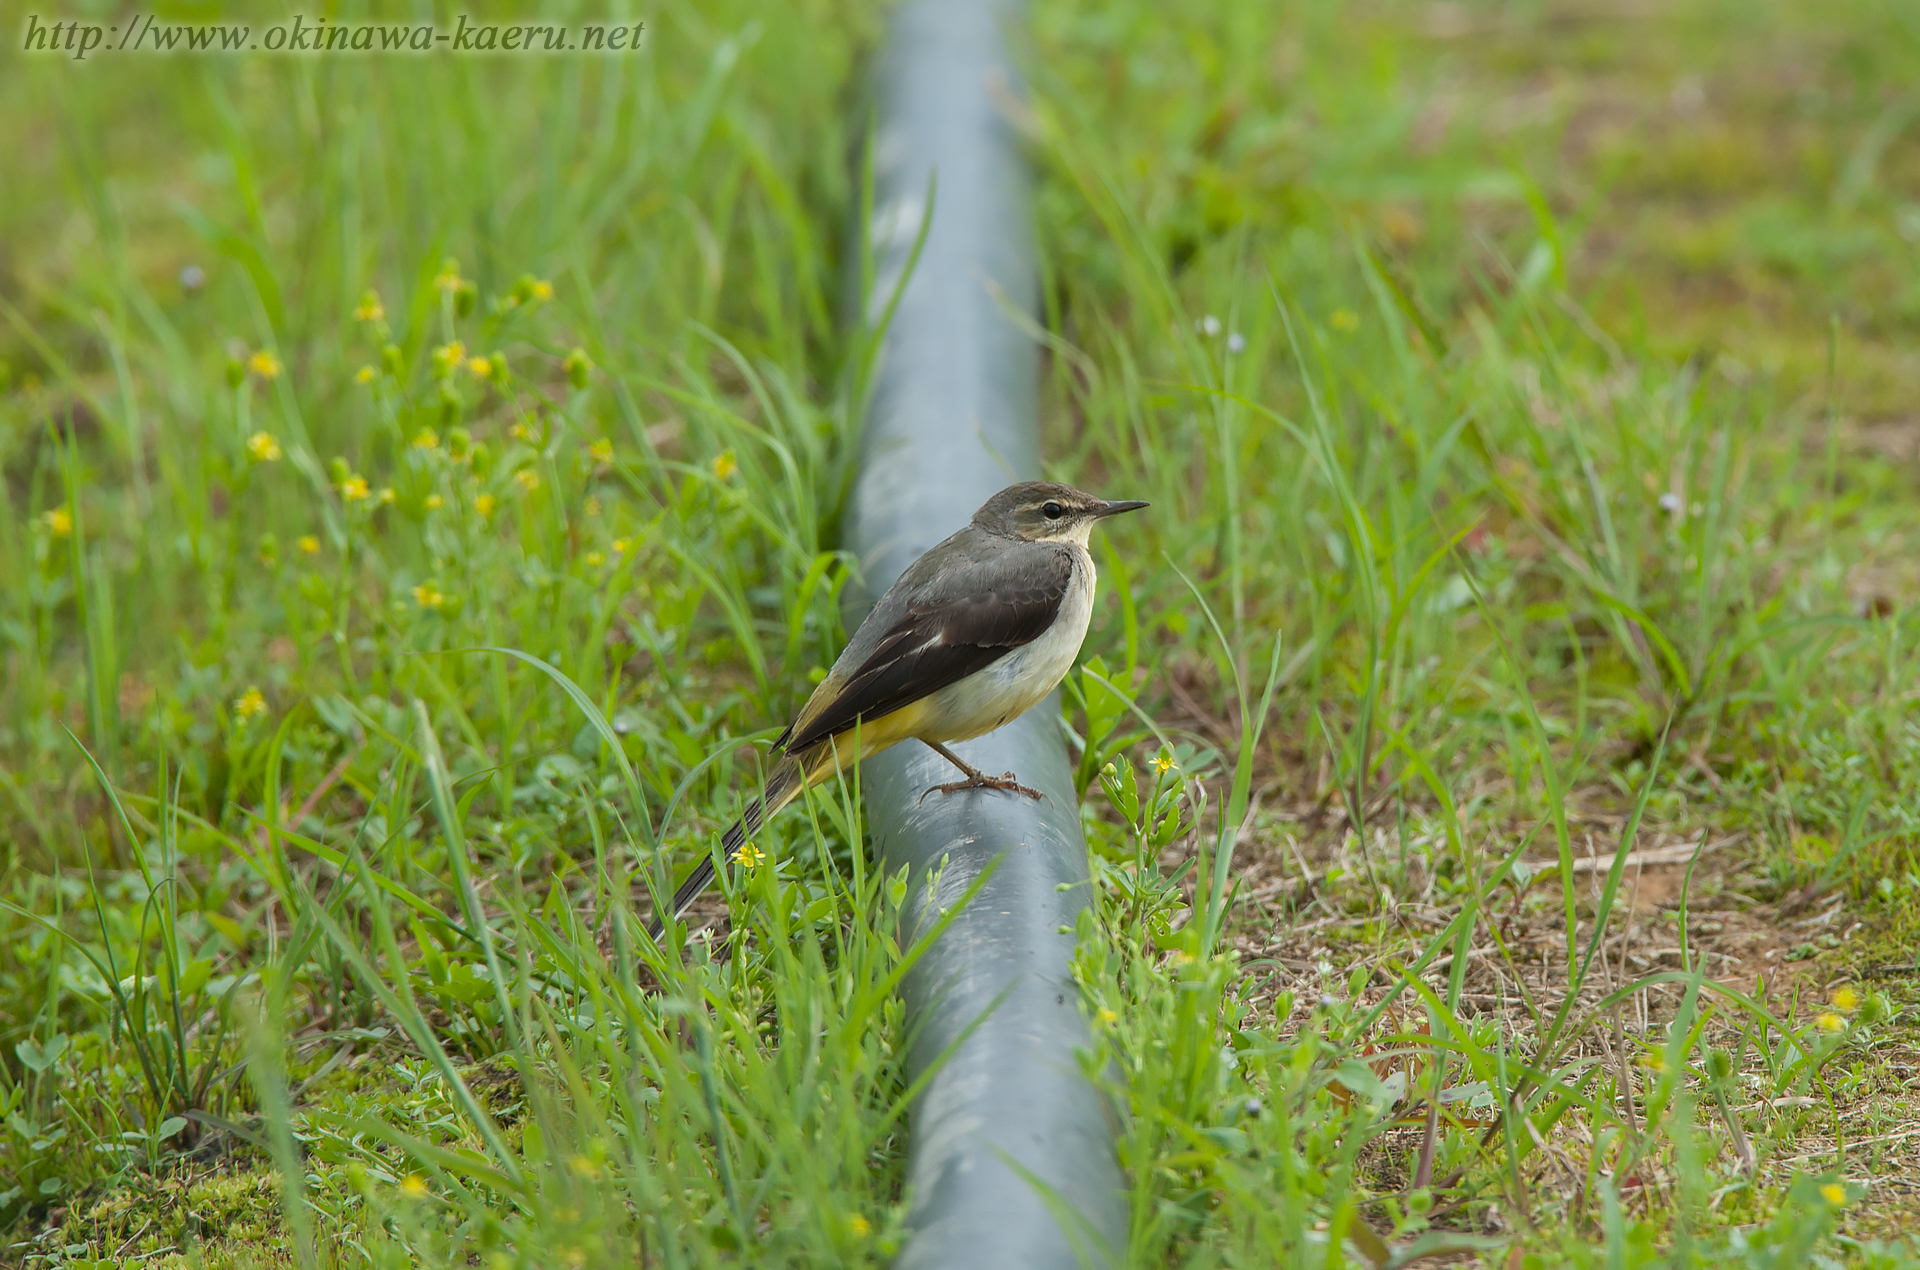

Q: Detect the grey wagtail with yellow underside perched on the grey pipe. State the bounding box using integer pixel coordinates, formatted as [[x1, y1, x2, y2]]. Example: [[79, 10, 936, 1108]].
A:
[[653, 480, 1146, 938]]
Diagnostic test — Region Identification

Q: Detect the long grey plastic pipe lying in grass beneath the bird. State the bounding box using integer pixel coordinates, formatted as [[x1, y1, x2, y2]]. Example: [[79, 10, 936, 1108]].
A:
[[847, 0, 1127, 1270]]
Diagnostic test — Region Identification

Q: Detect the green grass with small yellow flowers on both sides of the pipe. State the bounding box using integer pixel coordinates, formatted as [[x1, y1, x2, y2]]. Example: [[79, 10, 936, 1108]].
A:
[[11, 0, 1920, 1266]]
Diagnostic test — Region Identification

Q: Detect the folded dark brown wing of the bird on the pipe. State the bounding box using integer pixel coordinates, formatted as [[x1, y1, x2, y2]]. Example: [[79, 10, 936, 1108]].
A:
[[781, 551, 1073, 753]]
